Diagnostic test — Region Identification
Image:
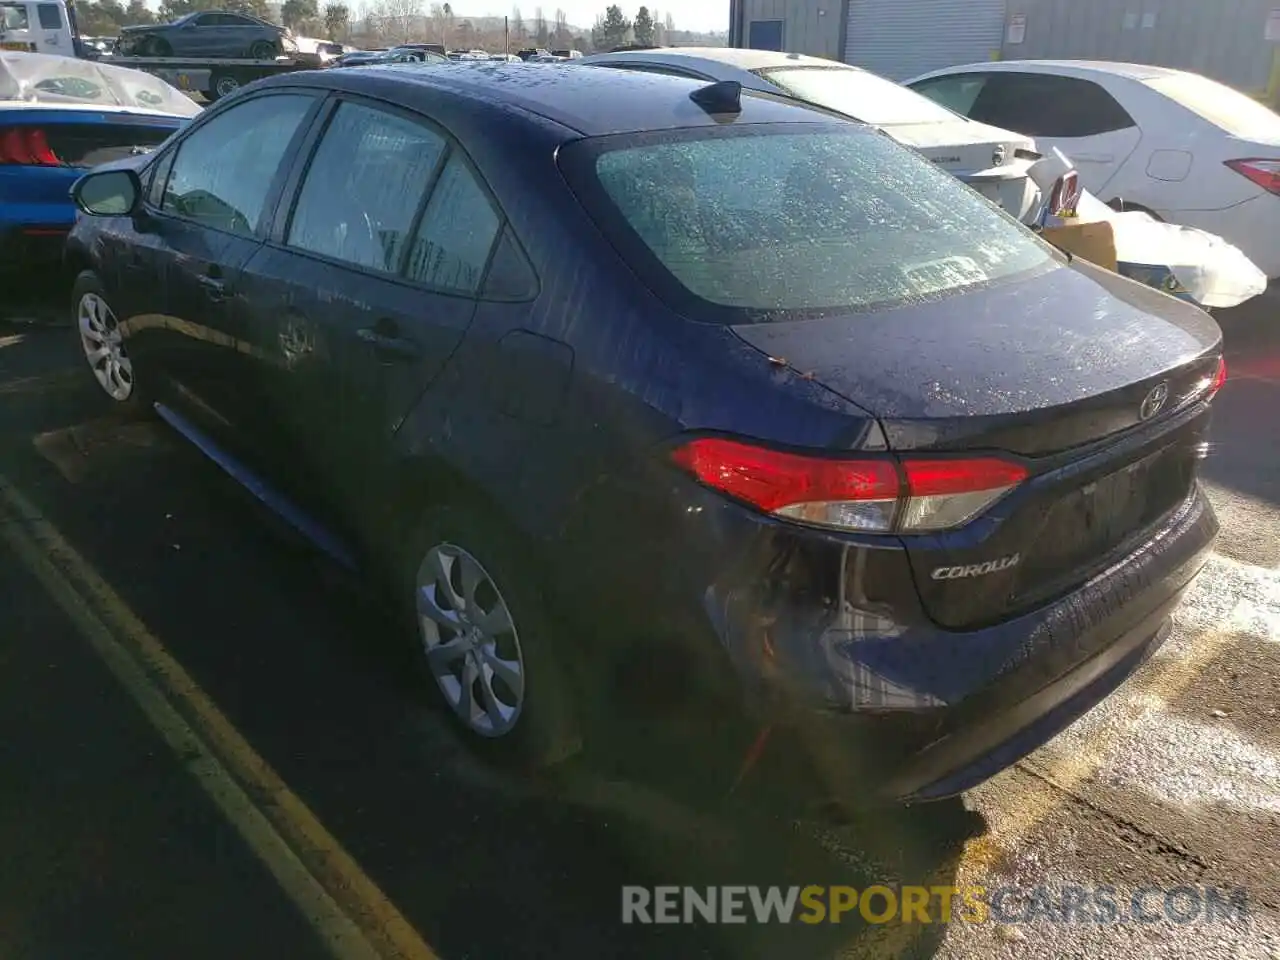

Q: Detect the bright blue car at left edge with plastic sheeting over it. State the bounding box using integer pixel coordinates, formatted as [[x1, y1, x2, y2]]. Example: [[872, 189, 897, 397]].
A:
[[0, 52, 201, 283]]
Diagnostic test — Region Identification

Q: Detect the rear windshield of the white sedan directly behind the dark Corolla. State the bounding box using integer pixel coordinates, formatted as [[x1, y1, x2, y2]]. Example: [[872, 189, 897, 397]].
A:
[[758, 67, 960, 127]]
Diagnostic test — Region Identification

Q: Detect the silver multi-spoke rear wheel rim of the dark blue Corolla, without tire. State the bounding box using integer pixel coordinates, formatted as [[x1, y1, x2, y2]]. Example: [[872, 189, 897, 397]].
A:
[[415, 543, 525, 737]]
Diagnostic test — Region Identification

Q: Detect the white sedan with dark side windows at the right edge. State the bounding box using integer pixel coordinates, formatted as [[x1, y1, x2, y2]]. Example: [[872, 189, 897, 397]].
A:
[[908, 60, 1280, 279]]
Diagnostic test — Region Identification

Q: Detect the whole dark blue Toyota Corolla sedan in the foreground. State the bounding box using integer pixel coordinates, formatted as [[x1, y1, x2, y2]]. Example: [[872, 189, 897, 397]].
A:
[[67, 64, 1226, 800]]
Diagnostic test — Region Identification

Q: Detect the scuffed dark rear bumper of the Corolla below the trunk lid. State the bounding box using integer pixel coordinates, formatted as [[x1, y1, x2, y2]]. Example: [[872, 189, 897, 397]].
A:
[[711, 486, 1219, 803]]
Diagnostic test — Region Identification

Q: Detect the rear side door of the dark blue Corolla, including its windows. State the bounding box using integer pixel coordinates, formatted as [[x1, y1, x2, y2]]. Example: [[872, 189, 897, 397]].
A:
[[232, 100, 500, 522]]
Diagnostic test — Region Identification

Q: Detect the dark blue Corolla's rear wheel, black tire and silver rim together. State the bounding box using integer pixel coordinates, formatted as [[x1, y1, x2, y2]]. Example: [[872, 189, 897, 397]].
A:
[[396, 506, 582, 773]]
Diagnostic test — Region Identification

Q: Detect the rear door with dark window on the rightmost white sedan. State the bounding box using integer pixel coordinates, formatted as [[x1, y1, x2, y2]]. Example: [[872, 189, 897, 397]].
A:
[[968, 73, 1142, 200]]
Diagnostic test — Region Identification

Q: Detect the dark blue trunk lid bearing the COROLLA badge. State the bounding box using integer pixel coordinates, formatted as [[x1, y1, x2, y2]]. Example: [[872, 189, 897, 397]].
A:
[[735, 259, 1221, 628]]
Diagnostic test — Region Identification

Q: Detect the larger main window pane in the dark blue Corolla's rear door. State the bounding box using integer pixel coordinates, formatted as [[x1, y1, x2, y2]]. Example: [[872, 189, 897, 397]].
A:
[[287, 102, 445, 274]]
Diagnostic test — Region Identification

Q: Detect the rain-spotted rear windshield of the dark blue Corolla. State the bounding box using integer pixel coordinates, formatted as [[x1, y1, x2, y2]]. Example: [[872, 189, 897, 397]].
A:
[[568, 124, 1060, 321]]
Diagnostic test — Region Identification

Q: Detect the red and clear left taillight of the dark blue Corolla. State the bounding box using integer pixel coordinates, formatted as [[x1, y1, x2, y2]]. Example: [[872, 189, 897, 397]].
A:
[[671, 438, 1027, 532]]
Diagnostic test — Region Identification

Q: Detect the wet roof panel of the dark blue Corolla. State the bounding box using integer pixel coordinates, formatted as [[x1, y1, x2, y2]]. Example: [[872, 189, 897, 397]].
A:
[[270, 60, 838, 137]]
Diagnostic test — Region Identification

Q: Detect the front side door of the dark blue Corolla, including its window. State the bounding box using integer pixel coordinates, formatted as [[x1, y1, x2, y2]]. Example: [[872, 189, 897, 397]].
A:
[[138, 92, 319, 430]]
